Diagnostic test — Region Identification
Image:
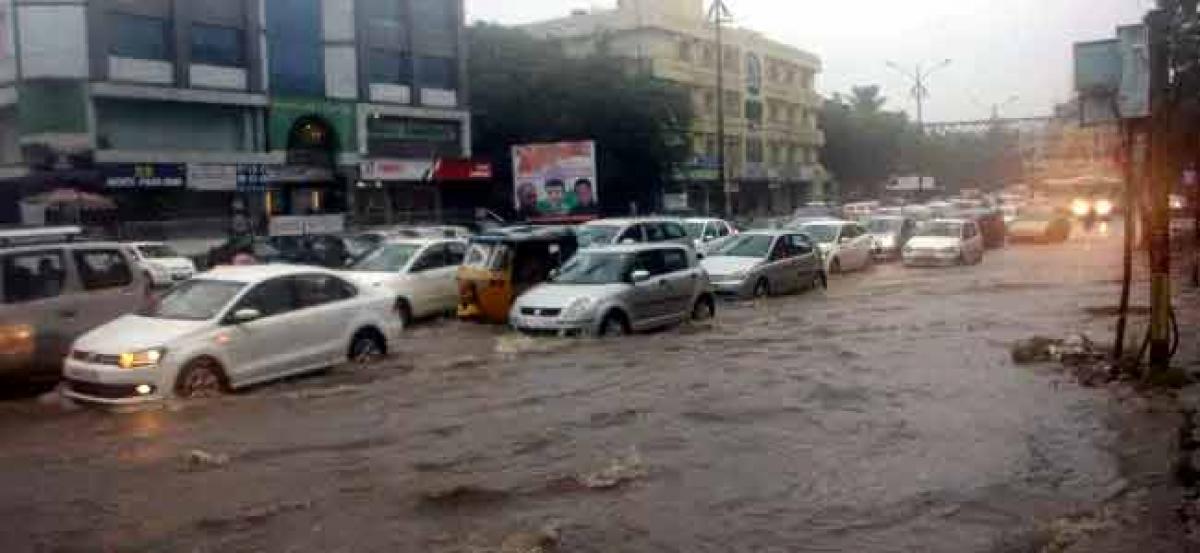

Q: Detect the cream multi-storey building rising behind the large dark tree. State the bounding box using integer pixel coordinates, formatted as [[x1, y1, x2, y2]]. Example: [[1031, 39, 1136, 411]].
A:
[[524, 0, 828, 216]]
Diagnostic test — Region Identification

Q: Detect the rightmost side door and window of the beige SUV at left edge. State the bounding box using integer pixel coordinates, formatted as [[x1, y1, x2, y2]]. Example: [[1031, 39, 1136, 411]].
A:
[[71, 246, 146, 332]]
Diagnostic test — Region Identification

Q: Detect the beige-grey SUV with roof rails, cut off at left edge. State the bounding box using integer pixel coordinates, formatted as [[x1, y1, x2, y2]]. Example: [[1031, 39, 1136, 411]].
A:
[[0, 228, 150, 384]]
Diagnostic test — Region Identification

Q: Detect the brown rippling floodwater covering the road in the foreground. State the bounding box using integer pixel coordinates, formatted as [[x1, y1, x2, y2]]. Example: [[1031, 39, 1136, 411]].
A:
[[0, 226, 1152, 553]]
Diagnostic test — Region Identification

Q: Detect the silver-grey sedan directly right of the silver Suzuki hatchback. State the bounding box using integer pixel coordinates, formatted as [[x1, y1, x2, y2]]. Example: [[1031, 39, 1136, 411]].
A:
[[700, 230, 827, 297]]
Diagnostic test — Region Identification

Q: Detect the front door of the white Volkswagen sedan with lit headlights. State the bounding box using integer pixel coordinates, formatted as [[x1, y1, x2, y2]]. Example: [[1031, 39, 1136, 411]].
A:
[[223, 276, 304, 385]]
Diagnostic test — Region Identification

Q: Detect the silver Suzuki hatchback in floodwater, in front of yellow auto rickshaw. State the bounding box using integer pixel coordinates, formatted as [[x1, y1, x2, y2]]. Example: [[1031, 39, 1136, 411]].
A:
[[509, 244, 716, 336]]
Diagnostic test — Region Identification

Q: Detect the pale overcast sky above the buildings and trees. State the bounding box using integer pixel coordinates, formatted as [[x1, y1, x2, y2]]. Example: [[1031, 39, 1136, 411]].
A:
[[466, 0, 1153, 121]]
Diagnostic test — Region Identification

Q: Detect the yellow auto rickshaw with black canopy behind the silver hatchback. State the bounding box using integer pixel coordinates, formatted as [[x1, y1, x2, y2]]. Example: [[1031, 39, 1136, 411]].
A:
[[458, 227, 578, 324]]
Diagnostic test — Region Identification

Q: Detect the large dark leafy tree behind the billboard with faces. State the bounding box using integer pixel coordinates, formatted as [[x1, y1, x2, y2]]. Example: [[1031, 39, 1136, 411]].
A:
[[467, 24, 692, 214]]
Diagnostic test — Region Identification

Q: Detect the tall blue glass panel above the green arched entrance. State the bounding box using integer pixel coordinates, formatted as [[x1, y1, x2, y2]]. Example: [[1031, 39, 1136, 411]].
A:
[[266, 0, 325, 96]]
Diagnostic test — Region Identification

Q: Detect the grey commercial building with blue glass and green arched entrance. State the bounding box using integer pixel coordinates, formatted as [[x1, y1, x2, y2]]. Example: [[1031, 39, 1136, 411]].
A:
[[0, 0, 470, 235]]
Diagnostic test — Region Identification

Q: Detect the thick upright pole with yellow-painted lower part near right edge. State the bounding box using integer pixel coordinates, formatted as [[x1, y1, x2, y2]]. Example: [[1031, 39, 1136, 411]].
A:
[[1146, 6, 1174, 373]]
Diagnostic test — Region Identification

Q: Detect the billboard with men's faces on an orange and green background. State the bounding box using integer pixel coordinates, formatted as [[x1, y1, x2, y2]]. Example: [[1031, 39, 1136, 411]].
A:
[[512, 142, 600, 221]]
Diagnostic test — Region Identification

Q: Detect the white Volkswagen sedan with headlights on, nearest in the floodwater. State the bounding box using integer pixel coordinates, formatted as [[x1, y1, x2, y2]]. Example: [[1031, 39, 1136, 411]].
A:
[[64, 265, 402, 404]]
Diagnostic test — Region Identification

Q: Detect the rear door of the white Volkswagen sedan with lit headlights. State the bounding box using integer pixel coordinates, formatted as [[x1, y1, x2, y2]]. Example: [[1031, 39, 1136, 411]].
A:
[[292, 274, 358, 367]]
